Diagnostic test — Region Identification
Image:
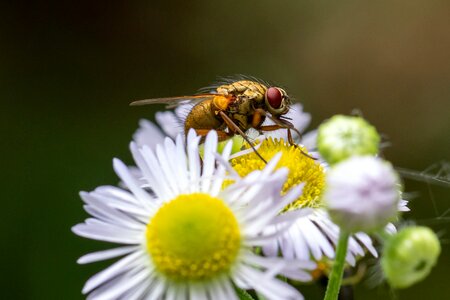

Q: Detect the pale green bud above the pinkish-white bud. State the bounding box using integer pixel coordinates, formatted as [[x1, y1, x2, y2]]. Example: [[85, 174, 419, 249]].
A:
[[317, 115, 380, 165]]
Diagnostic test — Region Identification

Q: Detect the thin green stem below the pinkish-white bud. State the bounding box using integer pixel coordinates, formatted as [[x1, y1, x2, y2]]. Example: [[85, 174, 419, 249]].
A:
[[325, 230, 350, 300]]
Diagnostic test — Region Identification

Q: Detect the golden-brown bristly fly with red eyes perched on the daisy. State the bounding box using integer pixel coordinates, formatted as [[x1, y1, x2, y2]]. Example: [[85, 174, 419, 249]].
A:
[[130, 76, 309, 162]]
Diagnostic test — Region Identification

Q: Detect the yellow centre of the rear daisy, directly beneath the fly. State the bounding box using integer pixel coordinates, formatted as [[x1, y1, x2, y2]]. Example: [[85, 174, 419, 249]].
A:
[[231, 138, 325, 211]]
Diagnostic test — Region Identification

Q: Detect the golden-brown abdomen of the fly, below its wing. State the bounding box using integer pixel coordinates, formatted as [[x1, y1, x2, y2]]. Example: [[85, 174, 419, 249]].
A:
[[184, 99, 223, 134]]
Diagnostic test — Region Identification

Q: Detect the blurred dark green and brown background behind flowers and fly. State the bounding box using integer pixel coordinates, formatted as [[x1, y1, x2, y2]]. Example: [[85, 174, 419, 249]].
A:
[[0, 0, 450, 299]]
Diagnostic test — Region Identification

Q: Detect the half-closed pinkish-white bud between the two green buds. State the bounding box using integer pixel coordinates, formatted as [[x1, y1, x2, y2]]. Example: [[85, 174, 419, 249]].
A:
[[323, 156, 400, 232]]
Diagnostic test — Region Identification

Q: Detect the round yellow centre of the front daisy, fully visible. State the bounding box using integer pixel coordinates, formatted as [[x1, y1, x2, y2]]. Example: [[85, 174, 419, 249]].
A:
[[146, 193, 241, 282]]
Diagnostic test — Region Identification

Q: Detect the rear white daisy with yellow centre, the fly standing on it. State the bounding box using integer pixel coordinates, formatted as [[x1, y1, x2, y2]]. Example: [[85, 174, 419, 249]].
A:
[[230, 138, 407, 266]]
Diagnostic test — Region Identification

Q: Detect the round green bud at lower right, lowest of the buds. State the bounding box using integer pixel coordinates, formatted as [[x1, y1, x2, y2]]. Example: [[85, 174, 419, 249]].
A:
[[381, 226, 441, 288]]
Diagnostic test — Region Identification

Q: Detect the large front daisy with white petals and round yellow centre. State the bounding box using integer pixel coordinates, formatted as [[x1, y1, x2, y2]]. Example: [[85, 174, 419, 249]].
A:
[[73, 130, 315, 299]]
